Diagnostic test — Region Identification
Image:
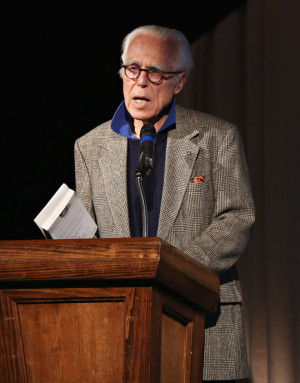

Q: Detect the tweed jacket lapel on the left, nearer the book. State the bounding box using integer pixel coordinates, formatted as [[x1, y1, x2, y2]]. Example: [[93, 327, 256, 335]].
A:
[[99, 134, 130, 237]]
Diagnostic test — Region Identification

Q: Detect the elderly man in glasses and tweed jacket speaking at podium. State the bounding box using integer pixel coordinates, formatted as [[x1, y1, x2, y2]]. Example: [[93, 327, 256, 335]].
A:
[[75, 26, 254, 382]]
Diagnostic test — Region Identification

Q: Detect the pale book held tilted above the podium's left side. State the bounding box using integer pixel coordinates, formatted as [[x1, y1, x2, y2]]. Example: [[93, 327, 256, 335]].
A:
[[34, 184, 97, 239]]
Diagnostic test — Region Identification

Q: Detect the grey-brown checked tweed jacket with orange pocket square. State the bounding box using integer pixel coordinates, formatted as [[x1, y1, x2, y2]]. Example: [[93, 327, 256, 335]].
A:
[[75, 105, 254, 380]]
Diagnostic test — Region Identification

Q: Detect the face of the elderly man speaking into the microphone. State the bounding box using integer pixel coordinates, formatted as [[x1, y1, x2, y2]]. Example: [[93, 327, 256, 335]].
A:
[[123, 35, 185, 131]]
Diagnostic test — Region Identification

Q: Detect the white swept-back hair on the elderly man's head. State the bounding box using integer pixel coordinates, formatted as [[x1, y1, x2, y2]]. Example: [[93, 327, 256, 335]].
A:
[[121, 25, 193, 76]]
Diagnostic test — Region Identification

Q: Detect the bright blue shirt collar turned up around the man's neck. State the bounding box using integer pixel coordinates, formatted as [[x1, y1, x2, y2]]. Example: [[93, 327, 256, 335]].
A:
[[111, 98, 176, 140]]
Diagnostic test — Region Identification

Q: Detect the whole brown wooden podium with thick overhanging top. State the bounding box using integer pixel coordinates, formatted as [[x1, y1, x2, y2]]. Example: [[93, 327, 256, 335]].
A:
[[0, 238, 219, 383]]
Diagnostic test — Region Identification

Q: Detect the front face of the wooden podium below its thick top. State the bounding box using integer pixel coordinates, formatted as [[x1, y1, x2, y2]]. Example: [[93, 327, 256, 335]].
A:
[[0, 287, 150, 383]]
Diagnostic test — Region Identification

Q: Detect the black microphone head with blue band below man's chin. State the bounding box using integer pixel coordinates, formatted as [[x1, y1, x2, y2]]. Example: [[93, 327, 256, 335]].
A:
[[139, 124, 156, 175]]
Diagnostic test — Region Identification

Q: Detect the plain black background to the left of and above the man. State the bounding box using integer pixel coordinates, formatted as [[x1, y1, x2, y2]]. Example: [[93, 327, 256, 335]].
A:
[[0, 0, 244, 239]]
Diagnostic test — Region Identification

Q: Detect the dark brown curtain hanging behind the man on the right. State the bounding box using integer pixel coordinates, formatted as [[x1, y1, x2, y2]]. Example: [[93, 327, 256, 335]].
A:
[[178, 0, 300, 383]]
